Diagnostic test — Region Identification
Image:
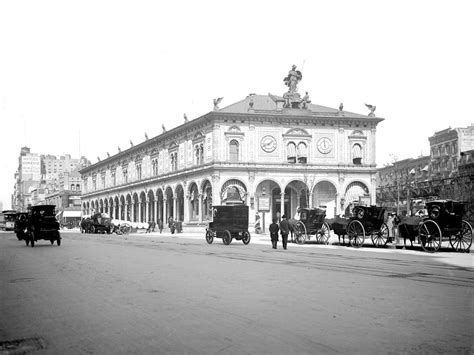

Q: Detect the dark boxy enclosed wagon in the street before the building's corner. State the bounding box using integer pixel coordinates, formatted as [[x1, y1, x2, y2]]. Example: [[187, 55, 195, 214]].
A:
[[206, 205, 250, 245]]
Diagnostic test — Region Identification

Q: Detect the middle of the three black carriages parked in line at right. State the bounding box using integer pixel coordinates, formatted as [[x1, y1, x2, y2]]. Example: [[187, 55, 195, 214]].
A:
[[346, 206, 390, 248]]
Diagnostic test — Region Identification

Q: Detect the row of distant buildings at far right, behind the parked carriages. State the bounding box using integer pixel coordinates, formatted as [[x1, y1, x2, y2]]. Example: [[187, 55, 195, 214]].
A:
[[377, 124, 474, 216]]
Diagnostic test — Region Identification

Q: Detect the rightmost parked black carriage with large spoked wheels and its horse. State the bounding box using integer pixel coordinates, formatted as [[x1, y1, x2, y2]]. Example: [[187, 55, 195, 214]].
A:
[[398, 200, 472, 253]]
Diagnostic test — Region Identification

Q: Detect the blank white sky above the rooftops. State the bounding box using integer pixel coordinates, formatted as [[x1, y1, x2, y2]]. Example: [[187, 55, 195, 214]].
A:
[[0, 0, 474, 208]]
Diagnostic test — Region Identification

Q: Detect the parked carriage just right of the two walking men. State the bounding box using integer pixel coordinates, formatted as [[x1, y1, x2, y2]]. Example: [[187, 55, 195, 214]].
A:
[[289, 208, 329, 244]]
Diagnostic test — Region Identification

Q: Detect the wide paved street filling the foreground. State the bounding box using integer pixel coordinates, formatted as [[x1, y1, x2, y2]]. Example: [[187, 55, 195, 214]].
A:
[[0, 231, 474, 354]]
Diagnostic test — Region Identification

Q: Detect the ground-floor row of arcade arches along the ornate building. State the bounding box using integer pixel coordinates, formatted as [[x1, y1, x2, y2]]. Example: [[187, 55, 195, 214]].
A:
[[82, 179, 370, 224]]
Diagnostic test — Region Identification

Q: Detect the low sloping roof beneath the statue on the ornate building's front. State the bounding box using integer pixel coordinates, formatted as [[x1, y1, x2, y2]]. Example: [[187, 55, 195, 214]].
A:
[[218, 94, 369, 118]]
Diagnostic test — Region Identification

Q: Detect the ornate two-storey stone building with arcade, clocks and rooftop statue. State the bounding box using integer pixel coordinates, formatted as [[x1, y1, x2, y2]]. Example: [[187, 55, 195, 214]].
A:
[[81, 68, 383, 231]]
